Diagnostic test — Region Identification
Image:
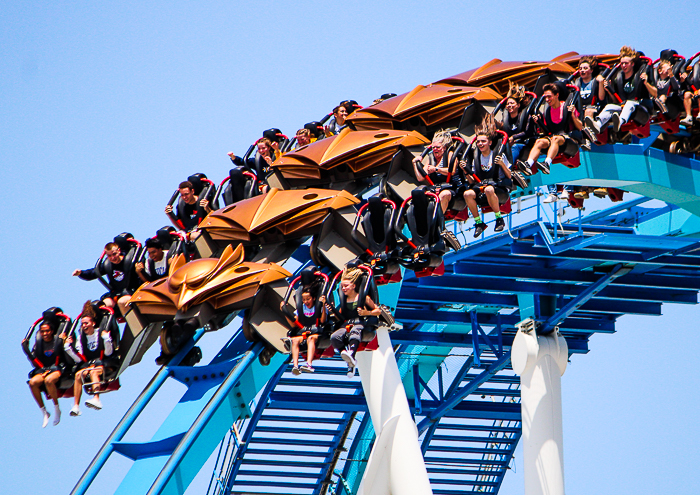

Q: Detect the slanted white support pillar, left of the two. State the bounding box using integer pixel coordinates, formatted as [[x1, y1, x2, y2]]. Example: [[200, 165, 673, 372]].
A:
[[357, 327, 433, 495]]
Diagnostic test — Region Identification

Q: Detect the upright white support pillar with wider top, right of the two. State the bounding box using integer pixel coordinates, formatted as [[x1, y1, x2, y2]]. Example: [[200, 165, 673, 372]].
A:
[[511, 320, 569, 495]]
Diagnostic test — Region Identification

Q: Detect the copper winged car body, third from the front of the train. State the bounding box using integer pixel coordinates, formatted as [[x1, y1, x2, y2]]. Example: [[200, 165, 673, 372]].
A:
[[268, 127, 428, 194]]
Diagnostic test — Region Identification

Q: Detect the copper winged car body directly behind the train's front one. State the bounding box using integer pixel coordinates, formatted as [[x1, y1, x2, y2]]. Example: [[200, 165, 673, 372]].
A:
[[195, 188, 360, 259]]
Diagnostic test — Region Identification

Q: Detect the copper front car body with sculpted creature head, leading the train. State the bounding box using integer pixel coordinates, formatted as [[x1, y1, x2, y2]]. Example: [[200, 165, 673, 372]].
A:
[[129, 245, 291, 321]]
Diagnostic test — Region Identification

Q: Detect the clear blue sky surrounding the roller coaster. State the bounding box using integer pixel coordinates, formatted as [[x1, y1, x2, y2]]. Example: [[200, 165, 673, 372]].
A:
[[0, 1, 700, 495]]
